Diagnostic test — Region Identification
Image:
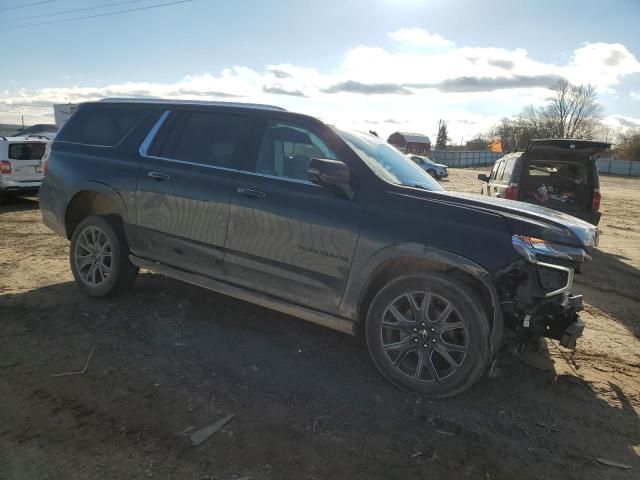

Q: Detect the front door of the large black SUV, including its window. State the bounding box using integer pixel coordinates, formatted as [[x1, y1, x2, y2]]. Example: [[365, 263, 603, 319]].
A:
[[225, 119, 362, 310]]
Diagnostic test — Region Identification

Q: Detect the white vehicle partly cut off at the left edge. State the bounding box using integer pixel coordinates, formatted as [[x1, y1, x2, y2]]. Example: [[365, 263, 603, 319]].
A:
[[0, 137, 47, 203]]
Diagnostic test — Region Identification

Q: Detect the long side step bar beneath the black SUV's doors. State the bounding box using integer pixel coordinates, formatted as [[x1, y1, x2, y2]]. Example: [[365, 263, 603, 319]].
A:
[[129, 255, 356, 335]]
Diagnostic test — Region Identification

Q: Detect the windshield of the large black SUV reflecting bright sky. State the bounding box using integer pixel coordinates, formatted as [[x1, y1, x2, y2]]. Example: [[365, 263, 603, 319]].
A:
[[333, 127, 444, 191]]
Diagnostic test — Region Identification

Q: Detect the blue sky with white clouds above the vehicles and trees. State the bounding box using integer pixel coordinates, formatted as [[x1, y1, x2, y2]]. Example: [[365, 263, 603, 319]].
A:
[[0, 0, 640, 143]]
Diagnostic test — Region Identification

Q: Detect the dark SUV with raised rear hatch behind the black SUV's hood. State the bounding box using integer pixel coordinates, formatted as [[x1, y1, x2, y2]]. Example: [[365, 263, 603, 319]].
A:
[[478, 139, 611, 225]]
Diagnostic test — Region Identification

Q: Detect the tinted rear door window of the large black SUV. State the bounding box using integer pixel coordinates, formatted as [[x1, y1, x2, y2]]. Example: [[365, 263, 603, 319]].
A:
[[150, 112, 247, 168]]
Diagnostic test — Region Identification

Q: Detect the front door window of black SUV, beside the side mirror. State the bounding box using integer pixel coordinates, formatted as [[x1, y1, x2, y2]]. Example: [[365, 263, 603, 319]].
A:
[[255, 121, 337, 180]]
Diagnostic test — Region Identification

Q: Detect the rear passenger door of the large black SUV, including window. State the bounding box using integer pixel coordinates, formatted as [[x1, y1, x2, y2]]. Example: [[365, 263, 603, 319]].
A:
[[132, 108, 250, 276]]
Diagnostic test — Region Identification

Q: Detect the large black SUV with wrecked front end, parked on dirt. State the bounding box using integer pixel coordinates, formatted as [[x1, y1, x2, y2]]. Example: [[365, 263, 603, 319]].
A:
[[40, 100, 598, 397]]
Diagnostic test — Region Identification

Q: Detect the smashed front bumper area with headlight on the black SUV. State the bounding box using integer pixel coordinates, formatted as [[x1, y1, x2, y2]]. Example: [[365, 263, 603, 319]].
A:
[[494, 235, 590, 349]]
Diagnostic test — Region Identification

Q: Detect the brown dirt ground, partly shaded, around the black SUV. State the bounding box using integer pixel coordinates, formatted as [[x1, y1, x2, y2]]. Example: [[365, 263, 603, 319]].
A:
[[0, 170, 640, 480]]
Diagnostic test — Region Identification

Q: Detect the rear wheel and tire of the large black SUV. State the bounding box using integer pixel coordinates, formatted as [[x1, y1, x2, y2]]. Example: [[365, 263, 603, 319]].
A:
[[69, 216, 139, 297]]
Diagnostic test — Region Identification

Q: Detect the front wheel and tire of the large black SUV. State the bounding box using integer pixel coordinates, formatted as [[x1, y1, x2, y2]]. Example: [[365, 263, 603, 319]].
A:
[[365, 273, 490, 397]]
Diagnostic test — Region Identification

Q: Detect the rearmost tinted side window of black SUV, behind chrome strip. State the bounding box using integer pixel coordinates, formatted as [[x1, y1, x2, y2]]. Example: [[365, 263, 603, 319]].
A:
[[56, 104, 146, 147]]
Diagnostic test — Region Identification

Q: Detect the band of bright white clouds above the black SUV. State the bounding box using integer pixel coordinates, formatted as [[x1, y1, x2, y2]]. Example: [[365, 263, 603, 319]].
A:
[[0, 29, 640, 141]]
